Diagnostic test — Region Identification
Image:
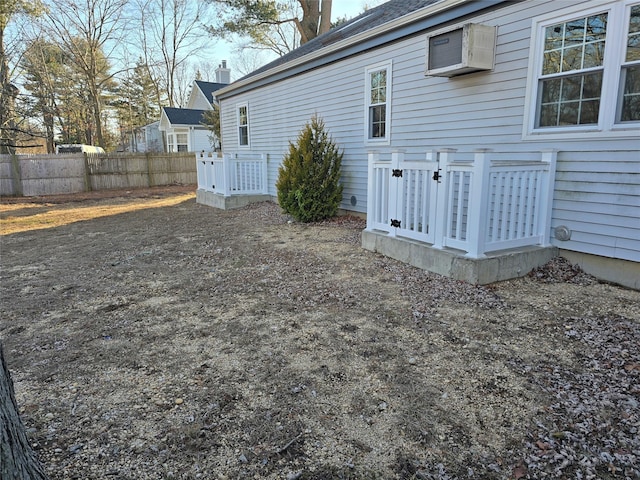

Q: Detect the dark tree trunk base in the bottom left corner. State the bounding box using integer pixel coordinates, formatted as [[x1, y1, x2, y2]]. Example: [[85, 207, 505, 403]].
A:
[[0, 344, 47, 480]]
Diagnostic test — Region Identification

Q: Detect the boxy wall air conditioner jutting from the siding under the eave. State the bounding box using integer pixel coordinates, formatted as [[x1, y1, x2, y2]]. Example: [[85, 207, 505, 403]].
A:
[[425, 23, 496, 77]]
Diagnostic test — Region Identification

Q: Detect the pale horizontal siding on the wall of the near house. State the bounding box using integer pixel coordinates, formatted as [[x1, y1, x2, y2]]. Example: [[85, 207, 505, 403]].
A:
[[221, 0, 640, 260]]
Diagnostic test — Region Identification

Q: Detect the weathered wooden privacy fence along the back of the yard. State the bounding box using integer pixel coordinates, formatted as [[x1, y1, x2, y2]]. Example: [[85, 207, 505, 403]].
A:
[[0, 152, 197, 196]]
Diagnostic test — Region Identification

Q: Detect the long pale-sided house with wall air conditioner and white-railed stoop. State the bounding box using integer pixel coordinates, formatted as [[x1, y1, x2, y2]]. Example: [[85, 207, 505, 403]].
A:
[[198, 0, 640, 288]]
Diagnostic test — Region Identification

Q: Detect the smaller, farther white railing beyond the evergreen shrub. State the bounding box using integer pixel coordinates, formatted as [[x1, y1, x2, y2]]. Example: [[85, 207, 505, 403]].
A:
[[196, 152, 268, 197]]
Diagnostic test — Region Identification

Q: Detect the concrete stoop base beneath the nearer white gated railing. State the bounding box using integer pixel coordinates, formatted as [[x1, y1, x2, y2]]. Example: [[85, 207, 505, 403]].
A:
[[362, 230, 558, 285]]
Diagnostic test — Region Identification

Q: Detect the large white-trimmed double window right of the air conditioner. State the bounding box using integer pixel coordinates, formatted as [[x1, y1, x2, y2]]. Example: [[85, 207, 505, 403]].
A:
[[527, 0, 640, 133]]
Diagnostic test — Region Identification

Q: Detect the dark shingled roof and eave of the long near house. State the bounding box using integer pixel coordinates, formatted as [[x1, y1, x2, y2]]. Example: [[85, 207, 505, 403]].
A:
[[216, 0, 510, 99]]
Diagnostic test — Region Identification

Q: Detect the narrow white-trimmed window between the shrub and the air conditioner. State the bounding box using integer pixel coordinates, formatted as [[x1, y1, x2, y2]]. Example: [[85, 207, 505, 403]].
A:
[[365, 62, 391, 143]]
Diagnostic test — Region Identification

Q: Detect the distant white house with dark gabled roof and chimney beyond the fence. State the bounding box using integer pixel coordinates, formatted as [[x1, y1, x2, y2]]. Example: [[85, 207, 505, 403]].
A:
[[159, 60, 230, 152]]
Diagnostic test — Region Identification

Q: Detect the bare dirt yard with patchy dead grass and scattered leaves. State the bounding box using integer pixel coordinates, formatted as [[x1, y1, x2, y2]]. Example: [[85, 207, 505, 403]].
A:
[[0, 187, 640, 480]]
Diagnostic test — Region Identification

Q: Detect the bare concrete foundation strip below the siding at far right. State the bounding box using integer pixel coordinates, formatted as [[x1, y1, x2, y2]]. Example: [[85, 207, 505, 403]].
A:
[[560, 250, 640, 290]]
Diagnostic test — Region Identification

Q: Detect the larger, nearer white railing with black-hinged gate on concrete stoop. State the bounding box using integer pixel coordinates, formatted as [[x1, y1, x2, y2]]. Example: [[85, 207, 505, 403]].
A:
[[367, 149, 556, 258]]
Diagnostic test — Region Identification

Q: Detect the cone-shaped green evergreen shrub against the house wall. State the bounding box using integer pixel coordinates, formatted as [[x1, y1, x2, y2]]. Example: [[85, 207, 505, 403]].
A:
[[276, 116, 343, 222]]
